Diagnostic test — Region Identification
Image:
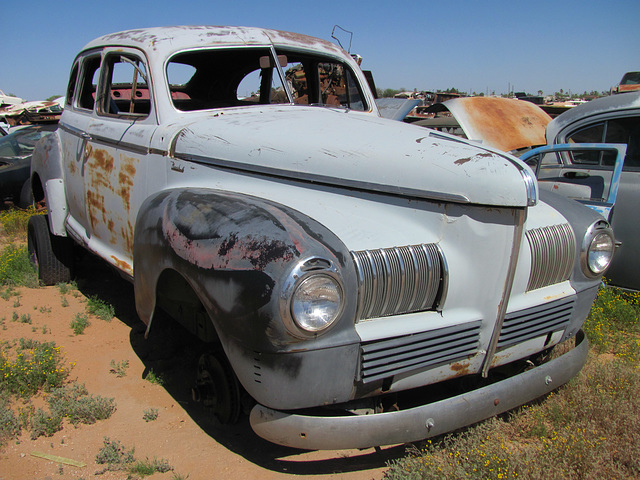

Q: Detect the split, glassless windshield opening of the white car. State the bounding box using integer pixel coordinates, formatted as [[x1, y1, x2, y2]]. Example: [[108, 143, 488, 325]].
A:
[[167, 48, 366, 111]]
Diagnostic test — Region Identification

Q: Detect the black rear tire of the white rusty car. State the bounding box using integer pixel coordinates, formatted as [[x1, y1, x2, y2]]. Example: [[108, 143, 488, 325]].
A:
[[27, 215, 73, 285]]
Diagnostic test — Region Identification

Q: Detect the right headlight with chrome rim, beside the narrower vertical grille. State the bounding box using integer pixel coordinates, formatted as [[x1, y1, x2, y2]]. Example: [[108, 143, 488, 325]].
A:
[[580, 219, 615, 278]]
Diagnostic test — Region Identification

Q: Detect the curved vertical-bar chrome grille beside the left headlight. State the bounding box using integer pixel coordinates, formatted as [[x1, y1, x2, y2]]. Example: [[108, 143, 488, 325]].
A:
[[351, 244, 447, 320]]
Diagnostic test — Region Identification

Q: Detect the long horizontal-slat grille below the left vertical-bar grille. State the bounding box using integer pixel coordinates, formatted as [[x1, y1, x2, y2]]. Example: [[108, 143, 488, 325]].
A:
[[360, 321, 482, 383]]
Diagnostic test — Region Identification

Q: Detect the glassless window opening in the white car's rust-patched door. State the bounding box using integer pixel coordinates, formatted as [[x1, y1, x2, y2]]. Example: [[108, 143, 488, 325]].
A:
[[99, 54, 151, 117]]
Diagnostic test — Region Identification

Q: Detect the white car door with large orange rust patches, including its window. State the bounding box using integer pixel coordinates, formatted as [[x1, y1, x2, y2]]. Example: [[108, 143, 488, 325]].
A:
[[82, 48, 157, 275]]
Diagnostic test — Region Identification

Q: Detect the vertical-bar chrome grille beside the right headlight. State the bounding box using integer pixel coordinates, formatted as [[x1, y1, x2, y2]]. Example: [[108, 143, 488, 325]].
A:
[[526, 223, 576, 292]]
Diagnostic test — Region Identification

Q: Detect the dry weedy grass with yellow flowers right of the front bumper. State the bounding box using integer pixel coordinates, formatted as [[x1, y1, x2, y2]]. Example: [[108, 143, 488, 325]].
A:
[[385, 288, 640, 480]]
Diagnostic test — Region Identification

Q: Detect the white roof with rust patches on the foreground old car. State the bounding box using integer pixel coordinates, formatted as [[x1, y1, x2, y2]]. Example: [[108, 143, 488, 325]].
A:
[[83, 25, 345, 56]]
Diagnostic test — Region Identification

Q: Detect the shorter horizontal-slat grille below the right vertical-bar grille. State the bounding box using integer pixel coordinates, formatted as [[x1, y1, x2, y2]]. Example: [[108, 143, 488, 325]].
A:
[[498, 296, 575, 348]]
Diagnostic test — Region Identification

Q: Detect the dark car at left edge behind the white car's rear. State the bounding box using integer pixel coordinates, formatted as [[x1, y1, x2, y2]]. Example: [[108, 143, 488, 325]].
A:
[[0, 124, 57, 208]]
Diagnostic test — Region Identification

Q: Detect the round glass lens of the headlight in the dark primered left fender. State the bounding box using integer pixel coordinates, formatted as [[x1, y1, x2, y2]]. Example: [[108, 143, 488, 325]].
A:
[[291, 274, 342, 332]]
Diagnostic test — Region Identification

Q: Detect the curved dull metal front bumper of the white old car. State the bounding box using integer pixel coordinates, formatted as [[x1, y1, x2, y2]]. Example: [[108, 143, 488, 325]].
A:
[[250, 331, 589, 450]]
